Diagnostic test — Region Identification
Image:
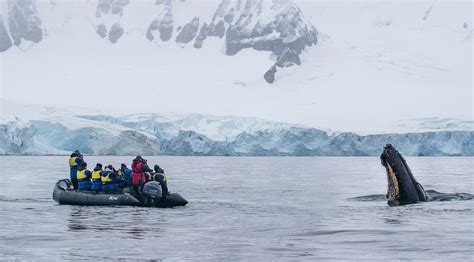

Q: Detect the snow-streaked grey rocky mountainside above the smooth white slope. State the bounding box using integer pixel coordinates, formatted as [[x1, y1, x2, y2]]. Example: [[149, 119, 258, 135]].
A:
[[0, 0, 318, 83]]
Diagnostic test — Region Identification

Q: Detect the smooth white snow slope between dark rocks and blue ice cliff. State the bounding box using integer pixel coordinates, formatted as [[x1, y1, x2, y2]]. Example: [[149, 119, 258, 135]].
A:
[[0, 1, 474, 131]]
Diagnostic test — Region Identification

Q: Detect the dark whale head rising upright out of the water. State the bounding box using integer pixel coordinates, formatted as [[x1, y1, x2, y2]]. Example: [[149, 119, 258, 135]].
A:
[[380, 144, 428, 206]]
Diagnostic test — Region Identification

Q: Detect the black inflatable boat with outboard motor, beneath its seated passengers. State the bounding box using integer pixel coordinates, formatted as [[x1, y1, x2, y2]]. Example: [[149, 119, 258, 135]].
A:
[[53, 179, 188, 208]]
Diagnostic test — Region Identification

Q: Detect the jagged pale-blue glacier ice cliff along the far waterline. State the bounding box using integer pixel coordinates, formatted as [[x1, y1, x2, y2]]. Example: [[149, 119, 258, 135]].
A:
[[0, 99, 474, 156]]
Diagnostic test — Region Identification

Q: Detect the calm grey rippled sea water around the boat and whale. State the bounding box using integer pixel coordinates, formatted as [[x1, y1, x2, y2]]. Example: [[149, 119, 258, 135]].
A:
[[0, 156, 474, 261]]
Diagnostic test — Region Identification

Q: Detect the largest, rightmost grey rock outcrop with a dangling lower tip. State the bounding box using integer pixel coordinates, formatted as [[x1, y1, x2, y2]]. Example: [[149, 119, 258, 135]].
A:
[[218, 0, 317, 83]]
